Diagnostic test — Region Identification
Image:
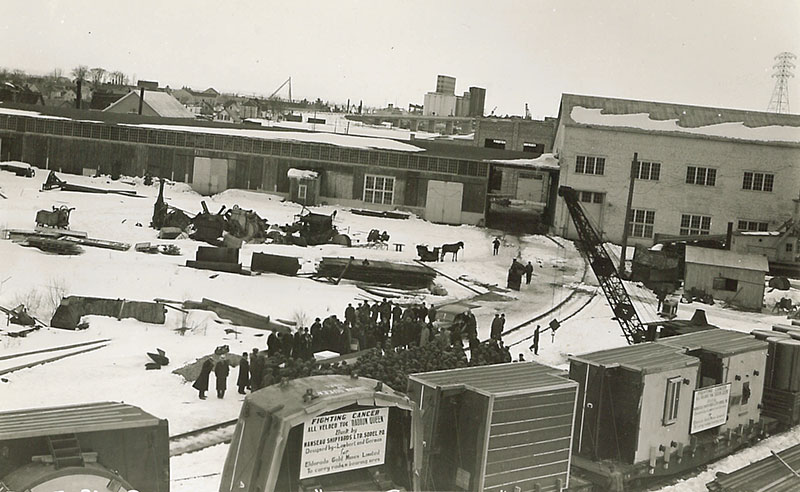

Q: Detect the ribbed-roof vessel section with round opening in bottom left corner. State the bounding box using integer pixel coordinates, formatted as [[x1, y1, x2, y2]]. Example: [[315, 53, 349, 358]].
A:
[[0, 403, 169, 492]]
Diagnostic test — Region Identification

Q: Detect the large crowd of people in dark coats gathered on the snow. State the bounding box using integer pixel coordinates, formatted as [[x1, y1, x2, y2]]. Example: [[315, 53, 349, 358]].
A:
[[193, 299, 511, 399]]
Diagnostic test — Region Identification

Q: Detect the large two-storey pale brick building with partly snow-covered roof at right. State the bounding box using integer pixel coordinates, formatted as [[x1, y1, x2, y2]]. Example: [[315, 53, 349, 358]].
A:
[[553, 94, 800, 245]]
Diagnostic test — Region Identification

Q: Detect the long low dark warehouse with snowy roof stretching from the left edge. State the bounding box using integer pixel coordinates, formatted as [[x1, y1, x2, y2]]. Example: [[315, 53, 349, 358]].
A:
[[0, 106, 536, 224]]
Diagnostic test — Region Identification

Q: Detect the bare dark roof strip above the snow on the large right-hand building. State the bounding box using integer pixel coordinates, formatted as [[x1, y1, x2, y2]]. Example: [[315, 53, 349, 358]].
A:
[[561, 94, 800, 138]]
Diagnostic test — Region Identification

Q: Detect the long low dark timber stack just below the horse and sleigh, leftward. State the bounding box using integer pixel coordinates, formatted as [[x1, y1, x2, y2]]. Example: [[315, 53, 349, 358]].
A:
[[317, 257, 436, 289]]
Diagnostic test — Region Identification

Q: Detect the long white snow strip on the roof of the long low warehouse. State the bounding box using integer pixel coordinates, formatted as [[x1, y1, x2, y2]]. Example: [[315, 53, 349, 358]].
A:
[[125, 124, 425, 152]]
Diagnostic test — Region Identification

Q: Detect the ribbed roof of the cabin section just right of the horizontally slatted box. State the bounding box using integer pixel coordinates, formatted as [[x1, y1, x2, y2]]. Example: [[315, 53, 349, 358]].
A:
[[570, 342, 700, 373]]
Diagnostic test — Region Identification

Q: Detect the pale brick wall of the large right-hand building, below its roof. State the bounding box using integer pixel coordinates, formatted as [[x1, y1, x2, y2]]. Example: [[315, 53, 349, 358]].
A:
[[553, 124, 800, 245]]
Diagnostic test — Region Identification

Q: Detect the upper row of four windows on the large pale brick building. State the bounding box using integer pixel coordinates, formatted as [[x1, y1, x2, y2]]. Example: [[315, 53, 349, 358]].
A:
[[575, 155, 775, 191]]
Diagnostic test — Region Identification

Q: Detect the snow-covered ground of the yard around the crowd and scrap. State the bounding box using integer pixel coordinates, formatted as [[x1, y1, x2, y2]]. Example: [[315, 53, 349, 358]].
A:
[[0, 166, 800, 492]]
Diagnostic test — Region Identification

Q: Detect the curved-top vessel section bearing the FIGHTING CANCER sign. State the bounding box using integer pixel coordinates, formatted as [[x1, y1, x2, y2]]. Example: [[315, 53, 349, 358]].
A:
[[219, 375, 413, 492]]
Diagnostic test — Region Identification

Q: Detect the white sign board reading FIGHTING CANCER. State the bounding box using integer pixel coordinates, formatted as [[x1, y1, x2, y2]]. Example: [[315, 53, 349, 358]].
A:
[[300, 408, 389, 479]]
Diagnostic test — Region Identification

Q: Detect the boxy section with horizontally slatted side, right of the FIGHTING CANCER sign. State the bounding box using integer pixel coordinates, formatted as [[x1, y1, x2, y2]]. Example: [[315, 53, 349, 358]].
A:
[[408, 362, 578, 492]]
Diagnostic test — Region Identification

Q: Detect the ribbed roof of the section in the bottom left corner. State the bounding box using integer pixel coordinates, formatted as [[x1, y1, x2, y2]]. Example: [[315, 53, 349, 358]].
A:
[[0, 402, 160, 441]]
